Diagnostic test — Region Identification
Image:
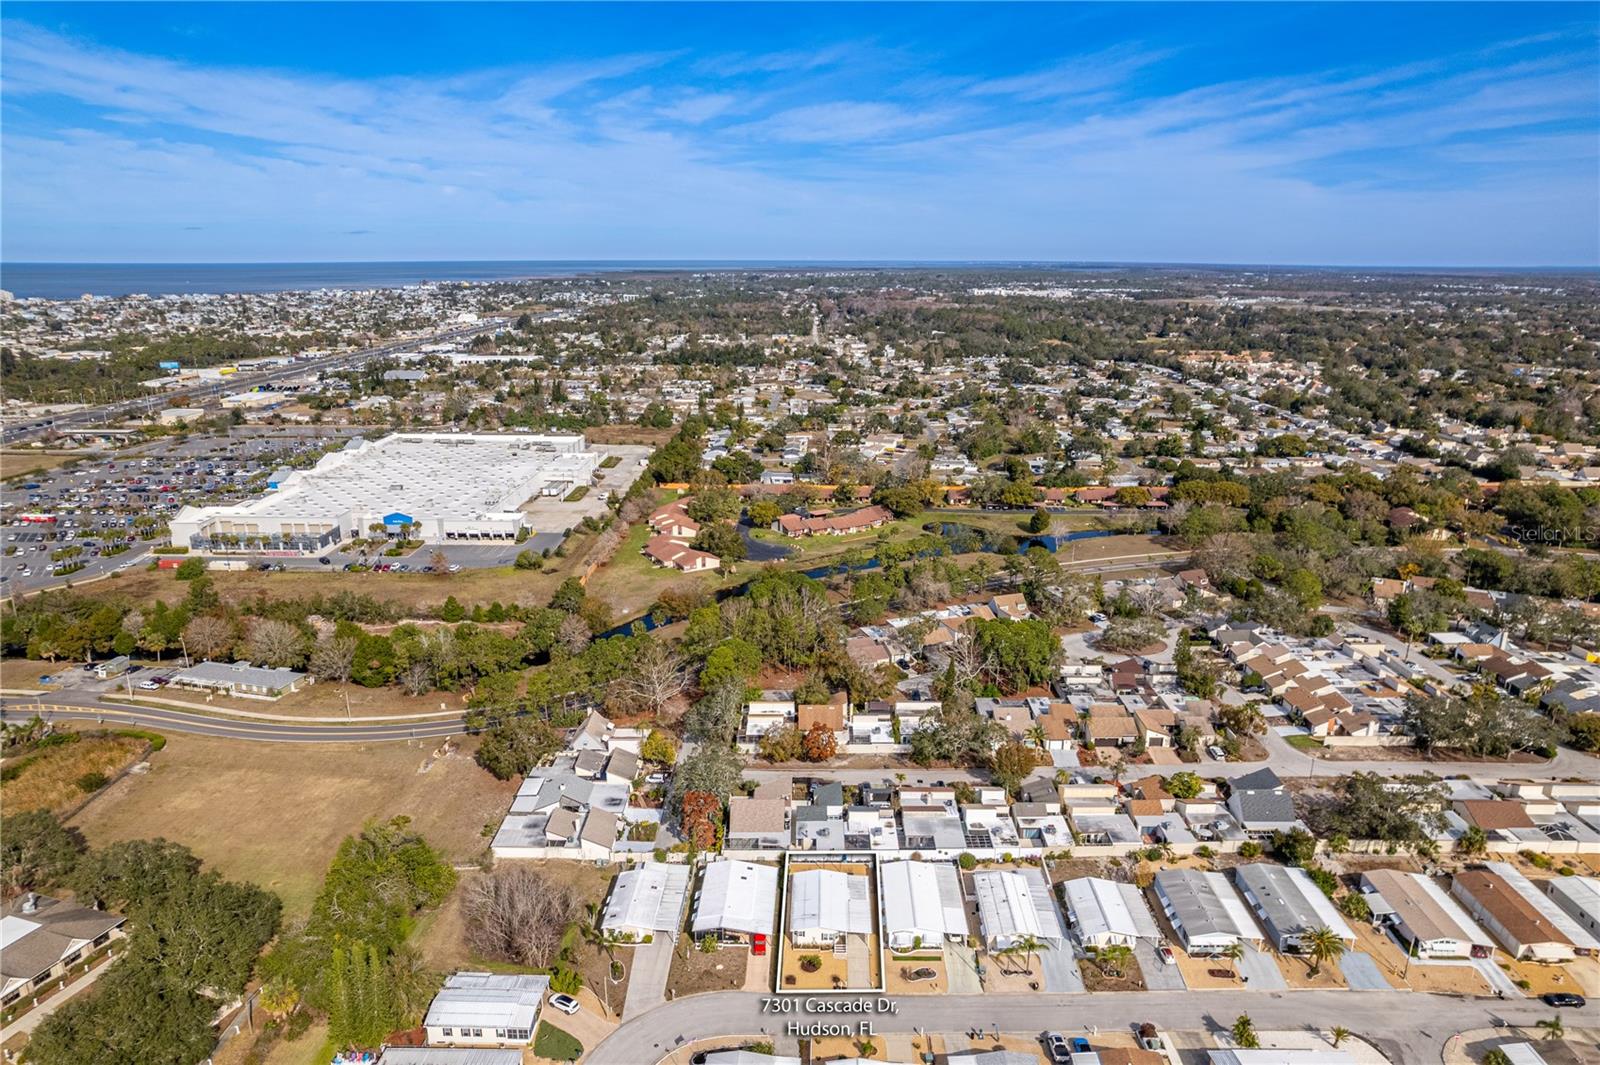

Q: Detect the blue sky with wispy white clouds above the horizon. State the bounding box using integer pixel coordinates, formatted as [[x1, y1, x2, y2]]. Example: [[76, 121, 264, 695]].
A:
[[0, 2, 1600, 267]]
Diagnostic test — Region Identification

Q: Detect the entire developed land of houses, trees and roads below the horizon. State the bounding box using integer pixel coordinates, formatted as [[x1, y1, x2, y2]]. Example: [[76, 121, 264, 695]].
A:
[[0, 267, 1600, 1065]]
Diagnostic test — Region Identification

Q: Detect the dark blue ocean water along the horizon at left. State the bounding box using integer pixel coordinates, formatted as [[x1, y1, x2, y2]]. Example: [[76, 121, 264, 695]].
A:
[[0, 259, 973, 299]]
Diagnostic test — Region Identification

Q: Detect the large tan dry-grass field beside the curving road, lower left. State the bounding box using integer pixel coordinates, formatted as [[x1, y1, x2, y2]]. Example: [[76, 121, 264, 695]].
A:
[[70, 734, 517, 919]]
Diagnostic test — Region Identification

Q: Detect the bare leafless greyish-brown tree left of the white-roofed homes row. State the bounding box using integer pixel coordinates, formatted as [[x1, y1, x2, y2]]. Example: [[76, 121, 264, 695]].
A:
[[461, 864, 582, 969]]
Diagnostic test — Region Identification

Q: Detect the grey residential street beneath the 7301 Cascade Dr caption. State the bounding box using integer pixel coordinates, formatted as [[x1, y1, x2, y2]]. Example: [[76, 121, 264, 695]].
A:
[[589, 991, 1600, 1065]]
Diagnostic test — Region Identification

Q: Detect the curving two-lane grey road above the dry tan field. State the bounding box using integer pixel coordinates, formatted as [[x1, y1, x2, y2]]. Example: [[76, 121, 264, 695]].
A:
[[0, 692, 466, 744]]
